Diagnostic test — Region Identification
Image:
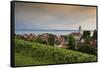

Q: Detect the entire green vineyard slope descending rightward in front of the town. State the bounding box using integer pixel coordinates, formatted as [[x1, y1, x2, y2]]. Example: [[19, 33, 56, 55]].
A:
[[15, 39, 96, 66]]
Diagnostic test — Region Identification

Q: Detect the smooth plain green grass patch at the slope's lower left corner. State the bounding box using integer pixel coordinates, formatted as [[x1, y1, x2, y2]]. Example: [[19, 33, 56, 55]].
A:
[[15, 53, 54, 66]]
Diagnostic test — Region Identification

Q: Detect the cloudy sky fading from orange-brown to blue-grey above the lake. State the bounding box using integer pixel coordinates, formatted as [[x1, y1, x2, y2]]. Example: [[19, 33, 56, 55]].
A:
[[15, 2, 96, 30]]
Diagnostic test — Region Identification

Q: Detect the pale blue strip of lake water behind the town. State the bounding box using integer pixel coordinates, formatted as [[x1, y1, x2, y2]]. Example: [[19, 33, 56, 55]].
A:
[[15, 30, 79, 35]]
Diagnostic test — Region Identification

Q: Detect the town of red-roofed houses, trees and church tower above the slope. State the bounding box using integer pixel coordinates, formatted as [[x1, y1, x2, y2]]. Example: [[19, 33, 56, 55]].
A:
[[16, 26, 97, 54]]
